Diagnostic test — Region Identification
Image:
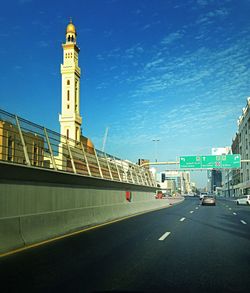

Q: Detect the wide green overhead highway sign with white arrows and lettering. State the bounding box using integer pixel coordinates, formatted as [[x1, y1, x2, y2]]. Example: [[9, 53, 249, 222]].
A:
[[180, 154, 241, 169]]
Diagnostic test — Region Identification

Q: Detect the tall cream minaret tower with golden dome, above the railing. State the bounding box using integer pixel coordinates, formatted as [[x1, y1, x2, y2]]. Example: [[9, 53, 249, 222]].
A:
[[59, 20, 82, 141]]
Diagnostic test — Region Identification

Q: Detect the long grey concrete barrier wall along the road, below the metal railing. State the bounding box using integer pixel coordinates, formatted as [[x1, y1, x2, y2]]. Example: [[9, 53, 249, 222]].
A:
[[0, 164, 178, 253]]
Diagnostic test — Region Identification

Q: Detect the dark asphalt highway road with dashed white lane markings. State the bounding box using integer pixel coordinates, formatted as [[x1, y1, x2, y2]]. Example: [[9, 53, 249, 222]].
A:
[[0, 198, 250, 293]]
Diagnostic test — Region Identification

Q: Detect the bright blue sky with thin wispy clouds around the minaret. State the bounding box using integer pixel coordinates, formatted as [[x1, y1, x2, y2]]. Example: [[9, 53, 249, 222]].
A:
[[0, 0, 250, 184]]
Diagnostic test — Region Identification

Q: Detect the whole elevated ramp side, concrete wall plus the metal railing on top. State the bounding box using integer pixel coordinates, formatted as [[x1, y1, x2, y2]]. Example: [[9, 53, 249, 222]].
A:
[[0, 110, 178, 256]]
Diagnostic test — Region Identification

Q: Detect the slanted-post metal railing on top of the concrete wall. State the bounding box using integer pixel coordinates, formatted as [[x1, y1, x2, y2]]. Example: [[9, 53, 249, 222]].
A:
[[0, 109, 156, 187]]
